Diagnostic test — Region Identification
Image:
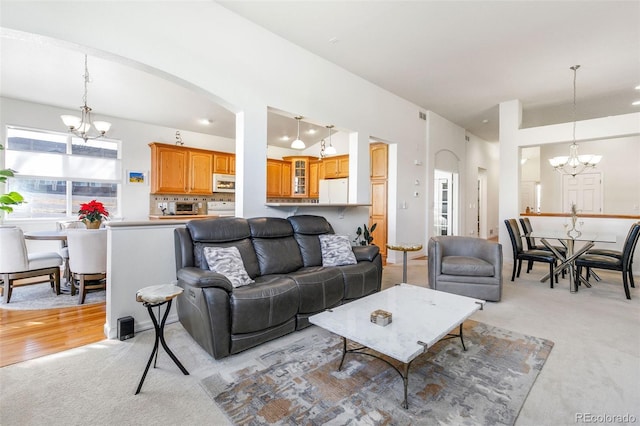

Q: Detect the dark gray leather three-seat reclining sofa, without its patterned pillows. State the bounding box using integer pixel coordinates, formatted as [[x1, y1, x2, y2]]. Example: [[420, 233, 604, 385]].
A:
[[175, 215, 382, 359]]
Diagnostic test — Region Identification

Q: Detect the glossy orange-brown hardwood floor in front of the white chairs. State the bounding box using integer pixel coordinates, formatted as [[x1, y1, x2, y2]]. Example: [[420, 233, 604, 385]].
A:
[[0, 302, 106, 367]]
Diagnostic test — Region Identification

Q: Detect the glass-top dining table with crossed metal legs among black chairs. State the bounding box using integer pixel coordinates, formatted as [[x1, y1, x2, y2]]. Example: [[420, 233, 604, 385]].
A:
[[526, 229, 616, 293]]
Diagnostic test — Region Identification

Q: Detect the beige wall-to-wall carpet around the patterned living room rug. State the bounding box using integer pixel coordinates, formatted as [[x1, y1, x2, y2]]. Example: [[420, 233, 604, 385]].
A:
[[0, 260, 640, 426]]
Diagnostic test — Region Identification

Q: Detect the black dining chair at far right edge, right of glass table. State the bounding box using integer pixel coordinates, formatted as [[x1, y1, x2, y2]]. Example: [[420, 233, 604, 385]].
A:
[[575, 223, 640, 299]]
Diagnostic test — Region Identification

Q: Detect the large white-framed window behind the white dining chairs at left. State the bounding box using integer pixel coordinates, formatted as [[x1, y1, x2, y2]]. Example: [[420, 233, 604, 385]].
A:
[[5, 127, 122, 219]]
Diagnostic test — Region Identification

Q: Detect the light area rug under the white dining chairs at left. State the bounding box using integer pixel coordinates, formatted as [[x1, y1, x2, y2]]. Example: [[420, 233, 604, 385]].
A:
[[0, 283, 107, 310]]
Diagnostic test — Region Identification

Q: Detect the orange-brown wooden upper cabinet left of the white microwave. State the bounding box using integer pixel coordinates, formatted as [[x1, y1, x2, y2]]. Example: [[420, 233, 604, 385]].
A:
[[149, 142, 213, 194]]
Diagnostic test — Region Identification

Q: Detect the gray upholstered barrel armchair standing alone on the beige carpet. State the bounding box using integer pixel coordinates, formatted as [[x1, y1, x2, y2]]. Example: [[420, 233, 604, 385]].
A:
[[427, 236, 502, 302]]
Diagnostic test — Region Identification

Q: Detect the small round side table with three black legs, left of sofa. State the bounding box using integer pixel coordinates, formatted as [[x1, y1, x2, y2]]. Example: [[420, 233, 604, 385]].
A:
[[135, 284, 189, 395]]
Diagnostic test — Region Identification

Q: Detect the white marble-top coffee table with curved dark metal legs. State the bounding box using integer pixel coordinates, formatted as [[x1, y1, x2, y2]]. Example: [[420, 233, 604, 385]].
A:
[[309, 284, 485, 408]]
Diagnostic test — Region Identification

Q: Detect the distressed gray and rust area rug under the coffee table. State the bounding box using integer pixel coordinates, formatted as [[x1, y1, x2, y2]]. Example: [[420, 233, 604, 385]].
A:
[[202, 320, 553, 425]]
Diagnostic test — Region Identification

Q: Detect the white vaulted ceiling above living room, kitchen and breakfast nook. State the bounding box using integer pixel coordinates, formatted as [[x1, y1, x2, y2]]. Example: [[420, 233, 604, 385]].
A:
[[0, 0, 640, 144]]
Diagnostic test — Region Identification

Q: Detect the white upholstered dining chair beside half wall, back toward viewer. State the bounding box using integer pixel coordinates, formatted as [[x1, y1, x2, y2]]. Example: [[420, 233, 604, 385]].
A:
[[67, 229, 107, 305]]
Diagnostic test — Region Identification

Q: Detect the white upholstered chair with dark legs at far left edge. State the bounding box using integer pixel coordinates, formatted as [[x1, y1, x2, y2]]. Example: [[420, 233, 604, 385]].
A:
[[0, 227, 62, 303]]
